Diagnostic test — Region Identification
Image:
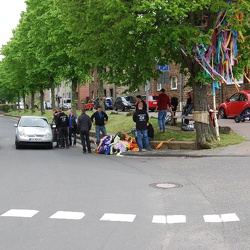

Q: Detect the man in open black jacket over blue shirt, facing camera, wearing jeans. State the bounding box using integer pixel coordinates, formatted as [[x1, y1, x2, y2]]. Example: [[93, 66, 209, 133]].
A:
[[91, 106, 108, 147]]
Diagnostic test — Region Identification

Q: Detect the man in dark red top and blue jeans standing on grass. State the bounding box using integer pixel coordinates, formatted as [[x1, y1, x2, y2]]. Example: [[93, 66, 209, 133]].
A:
[[155, 88, 171, 132]]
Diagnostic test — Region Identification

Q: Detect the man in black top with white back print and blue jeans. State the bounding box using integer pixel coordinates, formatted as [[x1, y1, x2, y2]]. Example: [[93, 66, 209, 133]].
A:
[[133, 103, 151, 152]]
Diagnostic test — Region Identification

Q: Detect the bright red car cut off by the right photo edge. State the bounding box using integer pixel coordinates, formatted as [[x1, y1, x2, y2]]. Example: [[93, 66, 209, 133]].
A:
[[218, 90, 250, 118]]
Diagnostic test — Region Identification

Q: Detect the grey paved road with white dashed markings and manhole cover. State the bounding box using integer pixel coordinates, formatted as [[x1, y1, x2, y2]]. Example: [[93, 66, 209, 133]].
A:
[[0, 117, 250, 250]]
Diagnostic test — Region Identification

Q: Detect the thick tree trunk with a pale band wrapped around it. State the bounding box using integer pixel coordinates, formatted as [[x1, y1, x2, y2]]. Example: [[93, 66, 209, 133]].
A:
[[193, 83, 216, 149]]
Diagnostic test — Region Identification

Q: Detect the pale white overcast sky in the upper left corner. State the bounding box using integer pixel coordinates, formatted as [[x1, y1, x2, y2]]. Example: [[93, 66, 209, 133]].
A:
[[0, 0, 26, 48]]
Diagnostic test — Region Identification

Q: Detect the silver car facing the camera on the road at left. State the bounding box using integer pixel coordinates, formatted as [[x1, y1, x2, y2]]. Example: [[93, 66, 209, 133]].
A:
[[15, 116, 53, 149]]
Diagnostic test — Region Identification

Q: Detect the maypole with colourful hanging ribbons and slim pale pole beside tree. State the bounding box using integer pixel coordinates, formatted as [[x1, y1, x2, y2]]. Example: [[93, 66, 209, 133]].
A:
[[194, 1, 244, 140]]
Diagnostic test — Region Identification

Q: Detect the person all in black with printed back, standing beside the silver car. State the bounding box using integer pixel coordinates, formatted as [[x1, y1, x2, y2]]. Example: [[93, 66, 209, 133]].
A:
[[56, 109, 69, 148]]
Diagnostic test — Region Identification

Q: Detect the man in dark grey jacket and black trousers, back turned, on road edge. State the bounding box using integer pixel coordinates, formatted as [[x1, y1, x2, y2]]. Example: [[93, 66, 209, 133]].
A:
[[77, 109, 92, 154]]
